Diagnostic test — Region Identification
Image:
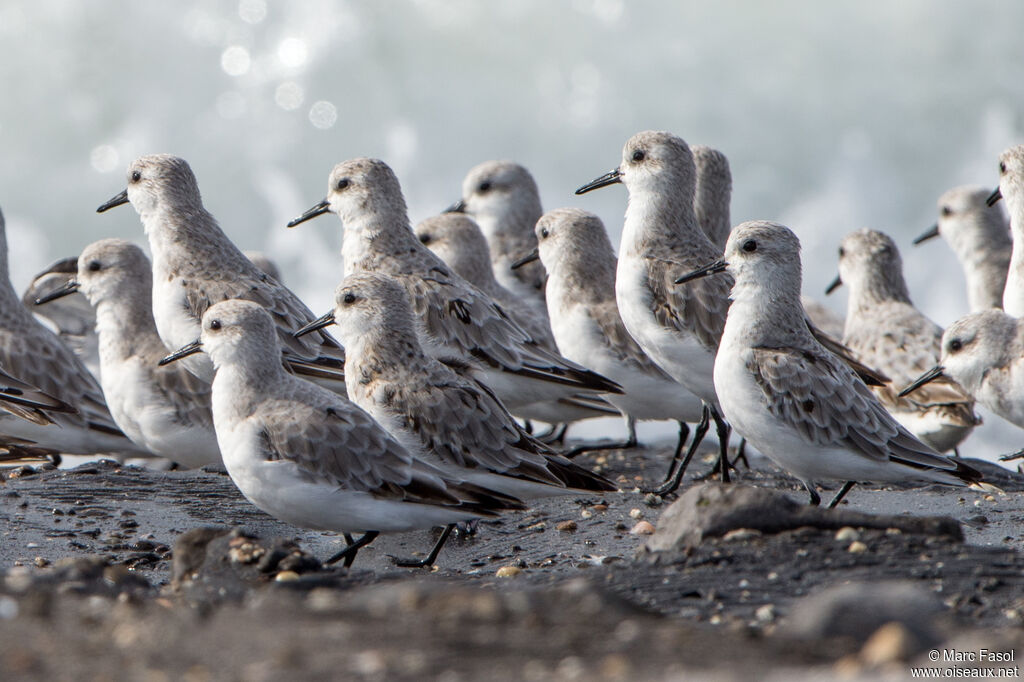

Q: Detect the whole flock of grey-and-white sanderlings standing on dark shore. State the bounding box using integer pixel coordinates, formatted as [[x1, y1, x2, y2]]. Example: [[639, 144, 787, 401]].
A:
[[0, 131, 1024, 565]]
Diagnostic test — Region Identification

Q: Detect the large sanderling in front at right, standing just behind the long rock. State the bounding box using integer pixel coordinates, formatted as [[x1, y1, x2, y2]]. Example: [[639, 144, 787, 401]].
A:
[[678, 221, 981, 507]]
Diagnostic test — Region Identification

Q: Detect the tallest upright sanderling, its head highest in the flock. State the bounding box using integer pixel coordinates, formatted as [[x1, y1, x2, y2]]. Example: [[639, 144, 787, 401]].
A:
[[577, 131, 731, 485]]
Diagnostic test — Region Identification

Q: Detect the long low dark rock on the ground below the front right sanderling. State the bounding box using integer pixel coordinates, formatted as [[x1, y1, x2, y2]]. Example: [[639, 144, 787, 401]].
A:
[[641, 482, 964, 553]]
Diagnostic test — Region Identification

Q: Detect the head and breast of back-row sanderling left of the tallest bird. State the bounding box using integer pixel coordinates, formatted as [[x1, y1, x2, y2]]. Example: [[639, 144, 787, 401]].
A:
[[447, 161, 547, 316]]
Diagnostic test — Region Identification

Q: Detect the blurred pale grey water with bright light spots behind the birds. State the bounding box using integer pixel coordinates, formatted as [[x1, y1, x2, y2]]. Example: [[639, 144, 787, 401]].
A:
[[0, 0, 1024, 455]]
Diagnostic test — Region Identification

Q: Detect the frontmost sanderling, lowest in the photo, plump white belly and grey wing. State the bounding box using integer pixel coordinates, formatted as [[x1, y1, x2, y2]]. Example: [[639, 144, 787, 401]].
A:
[[161, 300, 521, 565]]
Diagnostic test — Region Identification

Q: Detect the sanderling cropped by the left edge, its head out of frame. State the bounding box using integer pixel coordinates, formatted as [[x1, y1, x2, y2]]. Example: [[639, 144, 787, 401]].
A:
[[0, 201, 151, 457]]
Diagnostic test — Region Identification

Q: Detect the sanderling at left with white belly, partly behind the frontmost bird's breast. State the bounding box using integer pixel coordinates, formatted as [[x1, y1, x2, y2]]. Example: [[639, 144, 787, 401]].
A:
[[37, 240, 221, 467]]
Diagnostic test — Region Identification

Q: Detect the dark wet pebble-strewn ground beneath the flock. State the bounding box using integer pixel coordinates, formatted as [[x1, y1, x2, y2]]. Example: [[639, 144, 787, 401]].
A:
[[0, 440, 1024, 681]]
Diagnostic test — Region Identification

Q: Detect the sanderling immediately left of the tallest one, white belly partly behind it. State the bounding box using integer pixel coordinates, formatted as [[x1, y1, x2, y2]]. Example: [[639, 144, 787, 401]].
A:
[[516, 208, 701, 461]]
